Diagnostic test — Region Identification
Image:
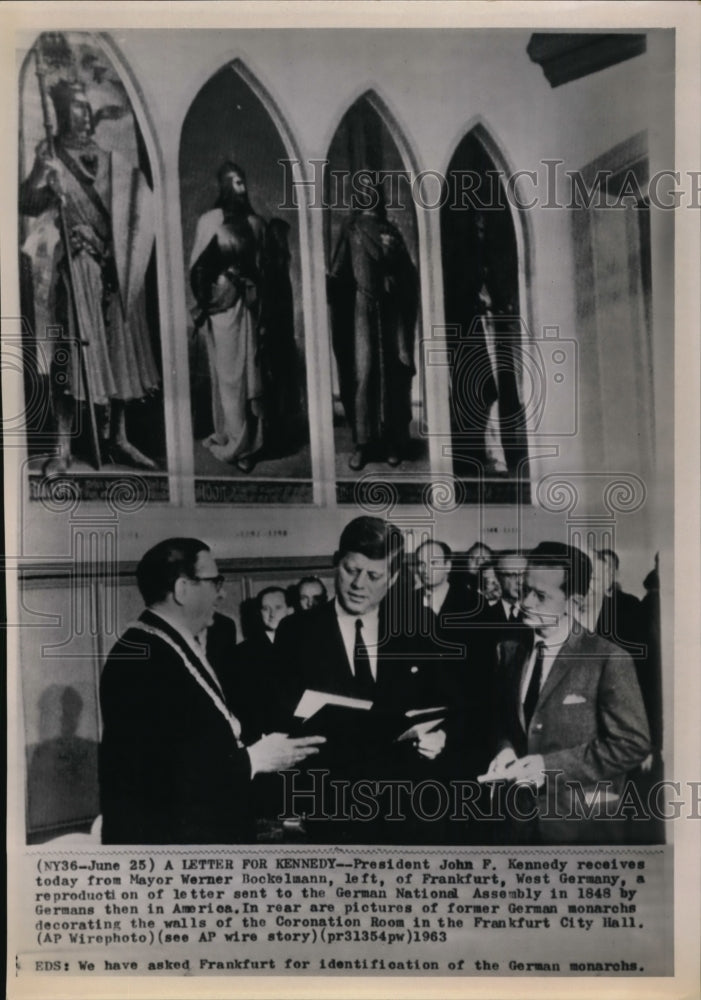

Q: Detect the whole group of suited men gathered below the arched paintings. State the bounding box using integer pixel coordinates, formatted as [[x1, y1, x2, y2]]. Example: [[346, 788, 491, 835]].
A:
[[100, 517, 662, 844]]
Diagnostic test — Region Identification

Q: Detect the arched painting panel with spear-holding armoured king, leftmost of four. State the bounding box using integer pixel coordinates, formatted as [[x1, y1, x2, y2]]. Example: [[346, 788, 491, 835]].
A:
[[19, 31, 168, 484]]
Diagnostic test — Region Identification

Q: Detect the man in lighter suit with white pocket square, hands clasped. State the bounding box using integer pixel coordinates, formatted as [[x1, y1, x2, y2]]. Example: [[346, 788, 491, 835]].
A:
[[483, 542, 650, 843]]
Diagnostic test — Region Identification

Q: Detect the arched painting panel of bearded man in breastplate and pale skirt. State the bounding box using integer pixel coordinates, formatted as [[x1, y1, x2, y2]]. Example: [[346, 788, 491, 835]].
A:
[[179, 60, 311, 502]]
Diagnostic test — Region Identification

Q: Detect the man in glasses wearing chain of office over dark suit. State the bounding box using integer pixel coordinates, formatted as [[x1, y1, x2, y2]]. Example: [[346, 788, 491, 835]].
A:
[[99, 538, 320, 844]]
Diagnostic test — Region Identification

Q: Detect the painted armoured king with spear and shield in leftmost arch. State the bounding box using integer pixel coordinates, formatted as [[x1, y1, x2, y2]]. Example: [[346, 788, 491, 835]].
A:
[[19, 79, 161, 476]]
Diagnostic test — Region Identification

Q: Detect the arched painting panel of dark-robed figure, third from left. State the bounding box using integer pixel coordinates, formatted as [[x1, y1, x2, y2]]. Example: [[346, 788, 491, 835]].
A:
[[324, 90, 429, 480]]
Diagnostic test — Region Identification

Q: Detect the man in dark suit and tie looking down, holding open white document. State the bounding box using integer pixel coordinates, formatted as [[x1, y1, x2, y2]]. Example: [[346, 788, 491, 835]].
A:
[[276, 517, 450, 843]]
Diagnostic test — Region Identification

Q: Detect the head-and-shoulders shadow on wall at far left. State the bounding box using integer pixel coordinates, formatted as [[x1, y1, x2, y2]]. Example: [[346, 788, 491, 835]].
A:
[[27, 684, 100, 844]]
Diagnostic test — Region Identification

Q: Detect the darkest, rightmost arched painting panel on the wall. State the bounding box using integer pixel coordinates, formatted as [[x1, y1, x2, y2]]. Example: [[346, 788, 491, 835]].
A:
[[441, 124, 528, 480]]
